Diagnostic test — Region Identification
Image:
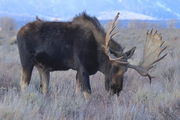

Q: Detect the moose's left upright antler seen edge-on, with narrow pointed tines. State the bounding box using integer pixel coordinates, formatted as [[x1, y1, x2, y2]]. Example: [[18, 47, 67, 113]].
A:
[[104, 12, 128, 64]]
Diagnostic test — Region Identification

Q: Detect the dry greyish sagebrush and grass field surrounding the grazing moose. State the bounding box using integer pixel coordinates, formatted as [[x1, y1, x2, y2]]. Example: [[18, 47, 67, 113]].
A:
[[0, 26, 180, 120]]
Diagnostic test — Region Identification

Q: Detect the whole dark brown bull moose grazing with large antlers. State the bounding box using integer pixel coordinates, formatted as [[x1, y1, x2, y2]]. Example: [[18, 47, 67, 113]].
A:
[[17, 13, 166, 99]]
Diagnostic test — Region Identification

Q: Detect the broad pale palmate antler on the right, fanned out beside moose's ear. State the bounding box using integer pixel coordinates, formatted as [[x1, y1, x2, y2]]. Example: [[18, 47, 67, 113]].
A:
[[128, 29, 167, 83]]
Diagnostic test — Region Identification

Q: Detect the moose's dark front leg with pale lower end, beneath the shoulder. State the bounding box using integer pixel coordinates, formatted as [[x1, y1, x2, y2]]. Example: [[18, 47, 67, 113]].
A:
[[76, 67, 91, 100]]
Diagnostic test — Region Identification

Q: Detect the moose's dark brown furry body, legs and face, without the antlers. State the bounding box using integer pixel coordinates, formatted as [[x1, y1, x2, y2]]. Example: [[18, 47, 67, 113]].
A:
[[17, 13, 133, 97]]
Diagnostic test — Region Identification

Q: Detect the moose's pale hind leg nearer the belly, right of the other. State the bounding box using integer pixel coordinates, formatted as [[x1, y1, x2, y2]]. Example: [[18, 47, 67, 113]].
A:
[[37, 67, 50, 94]]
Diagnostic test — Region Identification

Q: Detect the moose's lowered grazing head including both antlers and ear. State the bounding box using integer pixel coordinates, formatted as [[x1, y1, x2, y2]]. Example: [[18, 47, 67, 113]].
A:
[[104, 13, 167, 95]]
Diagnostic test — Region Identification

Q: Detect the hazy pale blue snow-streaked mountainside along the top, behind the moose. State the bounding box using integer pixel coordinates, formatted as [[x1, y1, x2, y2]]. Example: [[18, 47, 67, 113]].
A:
[[0, 0, 180, 19]]
